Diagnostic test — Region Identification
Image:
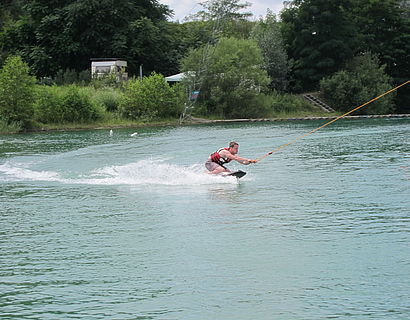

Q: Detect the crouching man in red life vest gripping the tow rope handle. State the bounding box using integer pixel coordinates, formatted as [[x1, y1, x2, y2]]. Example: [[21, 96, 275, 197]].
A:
[[205, 141, 257, 174]]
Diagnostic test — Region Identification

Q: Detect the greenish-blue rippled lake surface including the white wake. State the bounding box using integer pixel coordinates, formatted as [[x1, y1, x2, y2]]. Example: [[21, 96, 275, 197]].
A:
[[0, 119, 410, 320]]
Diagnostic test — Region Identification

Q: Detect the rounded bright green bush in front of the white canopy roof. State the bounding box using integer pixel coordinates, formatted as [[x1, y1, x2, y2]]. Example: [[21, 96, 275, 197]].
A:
[[119, 73, 182, 121]]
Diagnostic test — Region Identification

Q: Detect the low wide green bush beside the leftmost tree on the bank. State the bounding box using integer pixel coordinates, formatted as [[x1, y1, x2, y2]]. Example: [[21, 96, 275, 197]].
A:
[[35, 85, 103, 123]]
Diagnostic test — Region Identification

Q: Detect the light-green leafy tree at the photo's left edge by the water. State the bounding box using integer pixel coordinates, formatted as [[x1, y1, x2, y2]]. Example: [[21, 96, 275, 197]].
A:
[[0, 56, 36, 128]]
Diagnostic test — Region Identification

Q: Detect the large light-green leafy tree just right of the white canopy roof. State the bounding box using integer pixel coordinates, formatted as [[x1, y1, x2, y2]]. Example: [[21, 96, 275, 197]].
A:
[[182, 38, 269, 118]]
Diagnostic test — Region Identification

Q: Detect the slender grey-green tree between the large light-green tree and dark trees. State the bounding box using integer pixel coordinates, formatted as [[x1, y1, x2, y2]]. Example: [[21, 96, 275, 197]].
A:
[[252, 10, 290, 91]]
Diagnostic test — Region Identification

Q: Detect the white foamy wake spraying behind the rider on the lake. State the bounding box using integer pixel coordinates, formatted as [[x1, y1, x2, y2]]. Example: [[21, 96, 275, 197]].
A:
[[0, 160, 237, 186]]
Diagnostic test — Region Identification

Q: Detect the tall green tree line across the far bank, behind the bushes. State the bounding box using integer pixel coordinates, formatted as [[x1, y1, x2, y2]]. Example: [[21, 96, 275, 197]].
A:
[[0, 0, 410, 130]]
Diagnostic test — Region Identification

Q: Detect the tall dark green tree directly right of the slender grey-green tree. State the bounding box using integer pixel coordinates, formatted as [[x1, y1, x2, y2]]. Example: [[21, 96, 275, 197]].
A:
[[281, 0, 356, 91]]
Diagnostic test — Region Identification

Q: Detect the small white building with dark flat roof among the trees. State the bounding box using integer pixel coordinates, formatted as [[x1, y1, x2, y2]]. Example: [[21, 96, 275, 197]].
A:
[[90, 58, 128, 81]]
